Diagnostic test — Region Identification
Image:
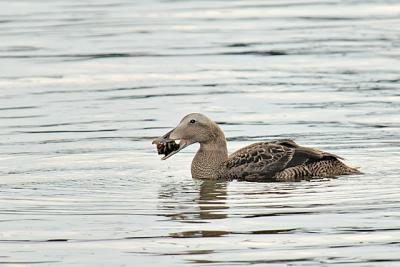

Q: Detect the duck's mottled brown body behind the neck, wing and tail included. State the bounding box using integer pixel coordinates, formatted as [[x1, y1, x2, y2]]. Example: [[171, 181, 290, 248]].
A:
[[220, 140, 360, 181]]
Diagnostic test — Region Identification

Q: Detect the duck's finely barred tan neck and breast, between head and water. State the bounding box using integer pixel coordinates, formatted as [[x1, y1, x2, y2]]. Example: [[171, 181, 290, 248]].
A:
[[192, 135, 228, 179]]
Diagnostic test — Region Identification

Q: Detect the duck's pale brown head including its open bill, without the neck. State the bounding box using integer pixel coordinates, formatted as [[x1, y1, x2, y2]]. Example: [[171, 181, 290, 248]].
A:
[[153, 113, 225, 160]]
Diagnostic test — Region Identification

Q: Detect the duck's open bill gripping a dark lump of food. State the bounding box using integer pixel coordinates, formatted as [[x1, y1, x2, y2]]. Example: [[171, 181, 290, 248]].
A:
[[153, 130, 192, 160]]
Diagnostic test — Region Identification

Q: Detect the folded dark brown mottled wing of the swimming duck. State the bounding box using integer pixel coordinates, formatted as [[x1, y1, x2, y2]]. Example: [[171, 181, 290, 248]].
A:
[[224, 139, 339, 181]]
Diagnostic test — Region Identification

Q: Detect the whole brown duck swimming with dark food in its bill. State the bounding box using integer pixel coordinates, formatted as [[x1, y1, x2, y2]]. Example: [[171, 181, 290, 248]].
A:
[[152, 113, 362, 182]]
